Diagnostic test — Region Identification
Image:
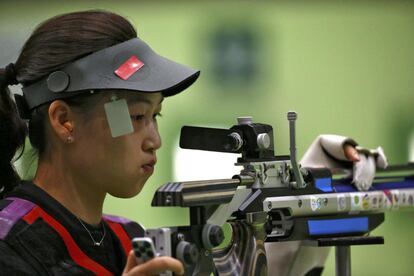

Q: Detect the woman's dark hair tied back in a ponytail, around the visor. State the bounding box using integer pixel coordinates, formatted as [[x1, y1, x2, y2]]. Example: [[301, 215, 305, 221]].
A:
[[0, 10, 137, 198]]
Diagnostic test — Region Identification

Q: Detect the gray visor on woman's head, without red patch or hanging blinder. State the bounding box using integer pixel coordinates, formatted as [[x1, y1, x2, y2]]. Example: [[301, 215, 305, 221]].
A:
[[23, 38, 200, 110]]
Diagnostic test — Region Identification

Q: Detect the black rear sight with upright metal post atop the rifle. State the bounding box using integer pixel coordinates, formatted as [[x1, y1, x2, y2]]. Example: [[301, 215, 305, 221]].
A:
[[180, 112, 306, 191]]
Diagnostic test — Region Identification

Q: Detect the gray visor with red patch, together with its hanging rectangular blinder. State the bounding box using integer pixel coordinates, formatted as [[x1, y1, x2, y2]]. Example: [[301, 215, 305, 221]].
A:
[[15, 38, 200, 137]]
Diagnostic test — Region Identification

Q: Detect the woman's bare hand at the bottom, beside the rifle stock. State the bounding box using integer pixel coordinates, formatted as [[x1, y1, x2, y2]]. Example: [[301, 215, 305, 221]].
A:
[[122, 250, 184, 276]]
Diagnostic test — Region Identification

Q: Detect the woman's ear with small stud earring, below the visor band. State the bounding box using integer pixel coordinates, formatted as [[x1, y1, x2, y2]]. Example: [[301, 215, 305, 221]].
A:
[[48, 100, 75, 143]]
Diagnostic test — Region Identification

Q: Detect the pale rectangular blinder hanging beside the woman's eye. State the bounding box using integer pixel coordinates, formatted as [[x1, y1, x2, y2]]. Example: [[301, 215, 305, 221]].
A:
[[104, 99, 134, 138]]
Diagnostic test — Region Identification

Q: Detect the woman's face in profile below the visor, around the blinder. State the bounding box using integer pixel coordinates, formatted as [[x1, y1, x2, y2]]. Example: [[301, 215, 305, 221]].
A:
[[71, 92, 163, 197]]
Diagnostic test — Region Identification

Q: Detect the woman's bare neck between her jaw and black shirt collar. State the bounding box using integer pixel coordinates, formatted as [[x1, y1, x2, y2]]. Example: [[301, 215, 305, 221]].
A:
[[33, 157, 106, 225]]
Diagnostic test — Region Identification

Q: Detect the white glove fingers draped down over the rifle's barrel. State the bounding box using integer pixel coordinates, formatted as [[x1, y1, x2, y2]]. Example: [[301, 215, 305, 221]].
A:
[[352, 147, 388, 191]]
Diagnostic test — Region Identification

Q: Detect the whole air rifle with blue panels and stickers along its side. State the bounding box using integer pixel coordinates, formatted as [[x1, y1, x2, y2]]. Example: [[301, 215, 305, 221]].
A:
[[146, 112, 414, 276]]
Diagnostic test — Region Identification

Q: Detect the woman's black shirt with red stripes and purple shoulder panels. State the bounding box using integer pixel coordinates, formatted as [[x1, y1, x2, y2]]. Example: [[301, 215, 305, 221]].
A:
[[0, 182, 144, 275]]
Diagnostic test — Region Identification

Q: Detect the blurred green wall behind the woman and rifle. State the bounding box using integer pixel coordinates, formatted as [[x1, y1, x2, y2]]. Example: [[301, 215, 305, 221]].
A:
[[0, 1, 414, 275]]
